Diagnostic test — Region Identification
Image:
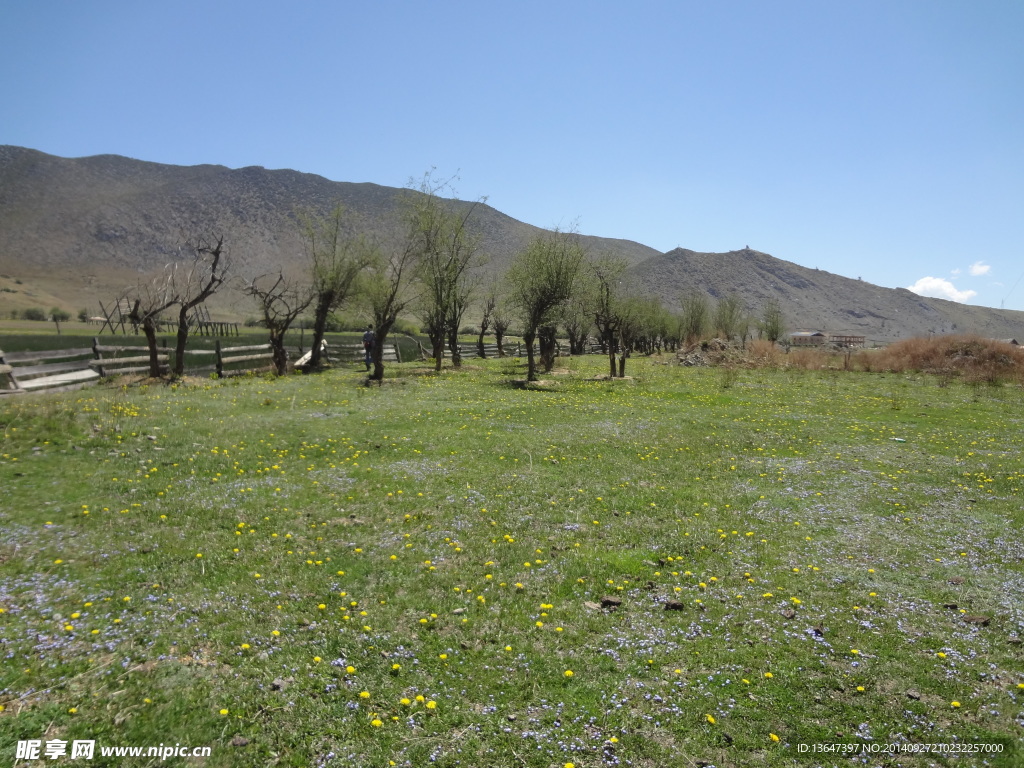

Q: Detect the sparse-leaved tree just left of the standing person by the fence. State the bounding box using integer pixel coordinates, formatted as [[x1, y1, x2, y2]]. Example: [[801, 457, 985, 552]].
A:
[[299, 203, 370, 371]]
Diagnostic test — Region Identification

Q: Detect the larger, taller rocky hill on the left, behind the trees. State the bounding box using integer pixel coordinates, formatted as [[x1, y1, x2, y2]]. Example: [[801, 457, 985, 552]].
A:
[[0, 146, 657, 314]]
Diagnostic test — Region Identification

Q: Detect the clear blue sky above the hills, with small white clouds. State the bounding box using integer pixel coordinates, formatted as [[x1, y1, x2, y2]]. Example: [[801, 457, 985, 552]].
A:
[[6, 0, 1024, 309]]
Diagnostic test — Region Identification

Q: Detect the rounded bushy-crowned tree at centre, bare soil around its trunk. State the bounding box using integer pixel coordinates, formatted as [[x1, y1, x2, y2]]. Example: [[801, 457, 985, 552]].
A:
[[508, 230, 584, 381]]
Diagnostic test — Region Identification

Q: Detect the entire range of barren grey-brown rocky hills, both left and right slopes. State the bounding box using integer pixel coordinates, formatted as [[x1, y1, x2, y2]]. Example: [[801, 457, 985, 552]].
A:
[[0, 146, 1024, 341]]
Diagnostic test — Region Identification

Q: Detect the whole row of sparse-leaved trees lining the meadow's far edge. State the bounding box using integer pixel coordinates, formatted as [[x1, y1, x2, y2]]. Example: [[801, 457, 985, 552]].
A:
[[123, 173, 782, 381]]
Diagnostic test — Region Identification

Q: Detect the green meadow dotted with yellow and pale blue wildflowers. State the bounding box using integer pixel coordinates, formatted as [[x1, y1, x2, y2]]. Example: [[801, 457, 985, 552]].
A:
[[0, 357, 1024, 768]]
